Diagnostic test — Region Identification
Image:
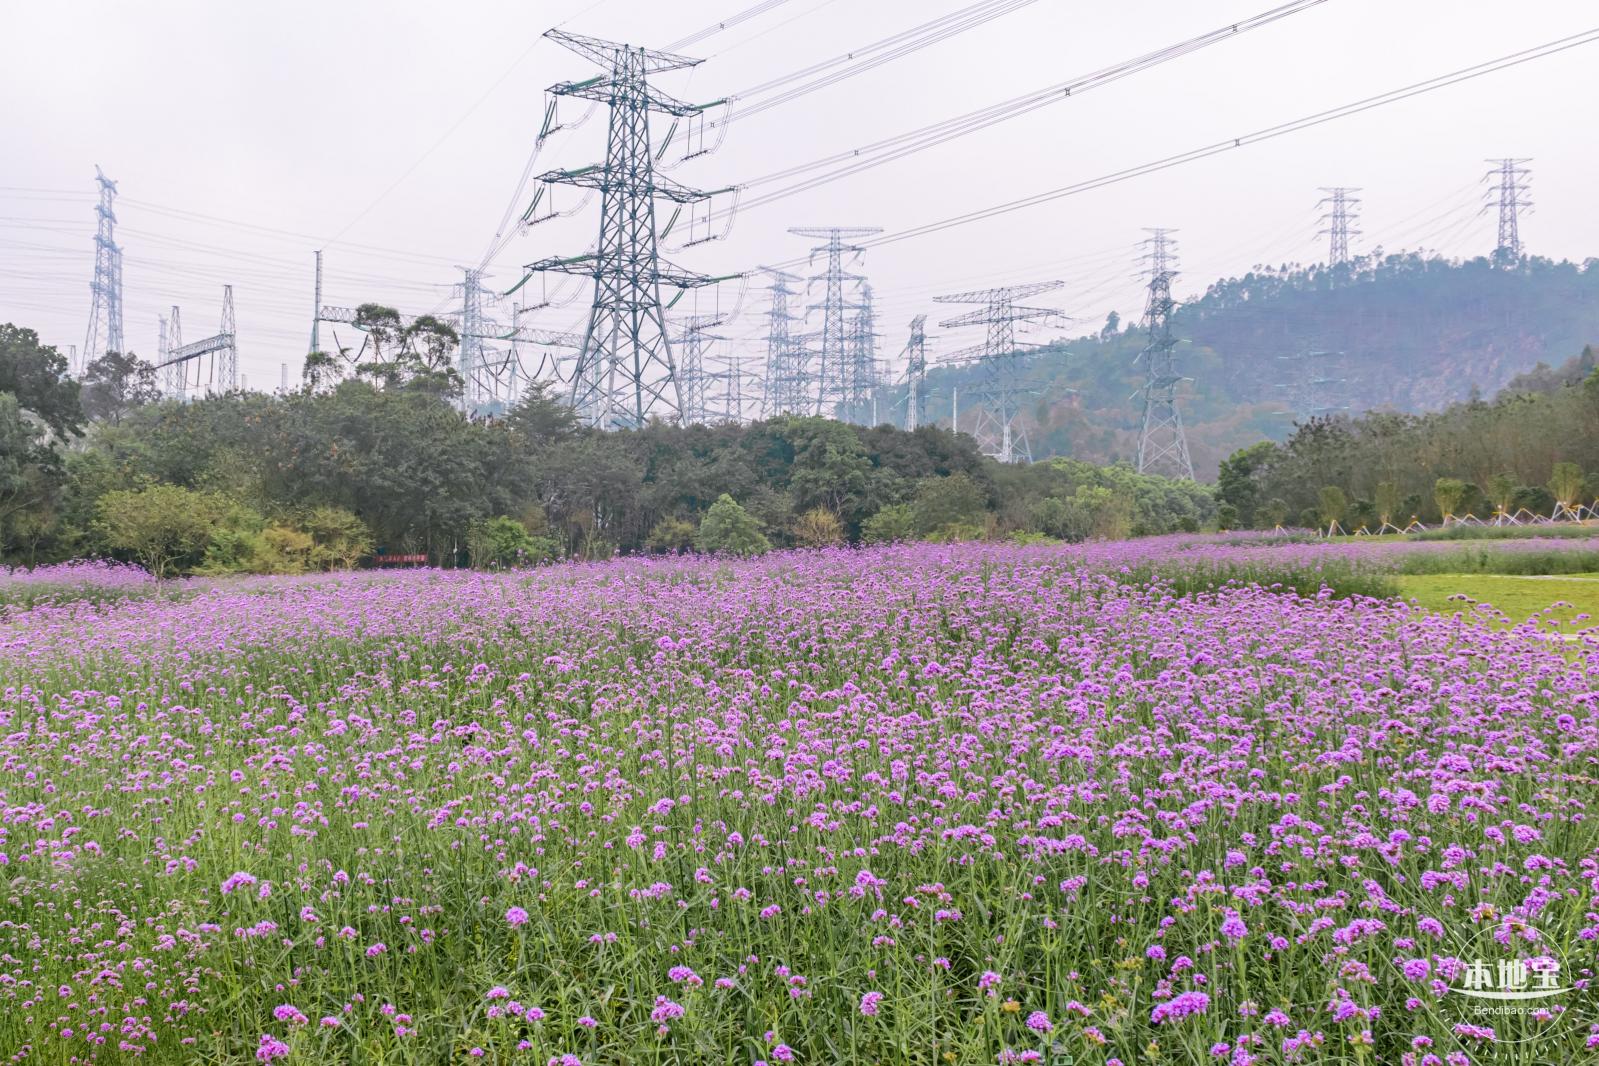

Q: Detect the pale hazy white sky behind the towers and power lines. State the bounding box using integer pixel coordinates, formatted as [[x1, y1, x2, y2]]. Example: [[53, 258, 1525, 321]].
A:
[[0, 0, 1599, 388]]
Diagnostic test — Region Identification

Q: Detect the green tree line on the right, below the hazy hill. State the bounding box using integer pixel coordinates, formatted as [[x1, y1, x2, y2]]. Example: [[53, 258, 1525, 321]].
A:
[[1217, 347, 1599, 532]]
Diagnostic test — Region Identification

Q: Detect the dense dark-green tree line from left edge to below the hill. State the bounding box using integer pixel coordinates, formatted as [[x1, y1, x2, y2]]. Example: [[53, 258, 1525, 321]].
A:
[[0, 319, 1215, 574]]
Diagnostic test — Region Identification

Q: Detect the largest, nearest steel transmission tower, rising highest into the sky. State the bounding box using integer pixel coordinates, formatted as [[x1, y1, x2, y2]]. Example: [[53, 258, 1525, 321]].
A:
[[528, 30, 724, 428]]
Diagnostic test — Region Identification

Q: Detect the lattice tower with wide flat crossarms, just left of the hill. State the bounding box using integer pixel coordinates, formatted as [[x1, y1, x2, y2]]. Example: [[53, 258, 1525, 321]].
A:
[[932, 281, 1063, 462]]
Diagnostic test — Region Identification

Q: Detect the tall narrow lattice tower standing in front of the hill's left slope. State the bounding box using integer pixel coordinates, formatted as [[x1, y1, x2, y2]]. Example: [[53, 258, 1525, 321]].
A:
[[1138, 229, 1194, 481]]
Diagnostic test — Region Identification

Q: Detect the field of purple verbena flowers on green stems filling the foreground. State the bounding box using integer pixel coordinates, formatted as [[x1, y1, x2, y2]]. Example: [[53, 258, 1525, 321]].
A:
[[0, 537, 1599, 1066]]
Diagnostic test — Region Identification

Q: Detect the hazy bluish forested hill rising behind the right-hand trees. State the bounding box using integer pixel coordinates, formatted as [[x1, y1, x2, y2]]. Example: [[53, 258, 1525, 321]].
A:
[[929, 254, 1599, 479]]
